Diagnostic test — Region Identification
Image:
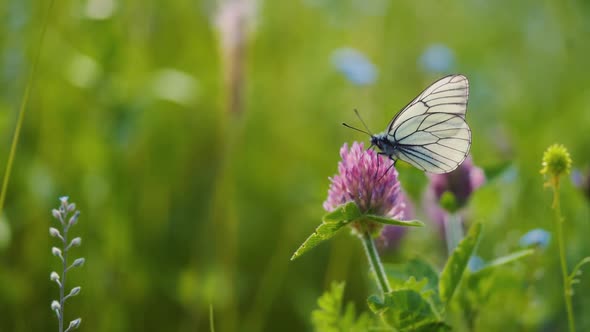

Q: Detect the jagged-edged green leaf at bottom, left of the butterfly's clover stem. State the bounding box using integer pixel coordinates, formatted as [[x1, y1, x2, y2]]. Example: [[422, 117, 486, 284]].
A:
[[311, 282, 371, 332]]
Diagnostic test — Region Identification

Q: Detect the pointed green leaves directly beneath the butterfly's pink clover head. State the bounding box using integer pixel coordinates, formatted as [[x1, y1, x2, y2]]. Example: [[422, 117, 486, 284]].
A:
[[291, 202, 424, 260]]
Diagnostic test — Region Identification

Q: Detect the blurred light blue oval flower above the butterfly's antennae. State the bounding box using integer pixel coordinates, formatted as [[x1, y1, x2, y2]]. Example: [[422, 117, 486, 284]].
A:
[[332, 48, 377, 85]]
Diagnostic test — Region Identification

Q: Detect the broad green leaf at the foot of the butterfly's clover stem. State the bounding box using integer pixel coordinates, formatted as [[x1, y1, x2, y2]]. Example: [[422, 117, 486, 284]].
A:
[[367, 289, 446, 331]]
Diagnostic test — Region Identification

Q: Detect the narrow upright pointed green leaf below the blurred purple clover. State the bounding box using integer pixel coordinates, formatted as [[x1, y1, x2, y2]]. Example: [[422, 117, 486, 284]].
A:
[[438, 223, 481, 304]]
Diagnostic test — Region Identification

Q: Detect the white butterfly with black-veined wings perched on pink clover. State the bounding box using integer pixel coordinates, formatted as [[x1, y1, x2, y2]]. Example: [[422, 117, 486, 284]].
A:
[[343, 75, 471, 174]]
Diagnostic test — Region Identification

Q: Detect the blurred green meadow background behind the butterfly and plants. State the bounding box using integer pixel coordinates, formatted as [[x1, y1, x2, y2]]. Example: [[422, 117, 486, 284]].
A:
[[0, 0, 590, 331]]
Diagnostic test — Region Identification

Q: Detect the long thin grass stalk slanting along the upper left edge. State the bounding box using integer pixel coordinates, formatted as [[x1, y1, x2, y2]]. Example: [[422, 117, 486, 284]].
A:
[[0, 0, 54, 214]]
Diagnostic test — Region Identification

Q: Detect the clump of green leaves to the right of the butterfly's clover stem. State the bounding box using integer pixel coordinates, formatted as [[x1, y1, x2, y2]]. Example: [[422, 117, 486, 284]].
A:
[[368, 223, 535, 331]]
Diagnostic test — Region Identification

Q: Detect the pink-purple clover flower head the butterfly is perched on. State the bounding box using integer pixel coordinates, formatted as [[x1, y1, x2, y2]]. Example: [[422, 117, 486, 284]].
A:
[[324, 142, 405, 218]]
